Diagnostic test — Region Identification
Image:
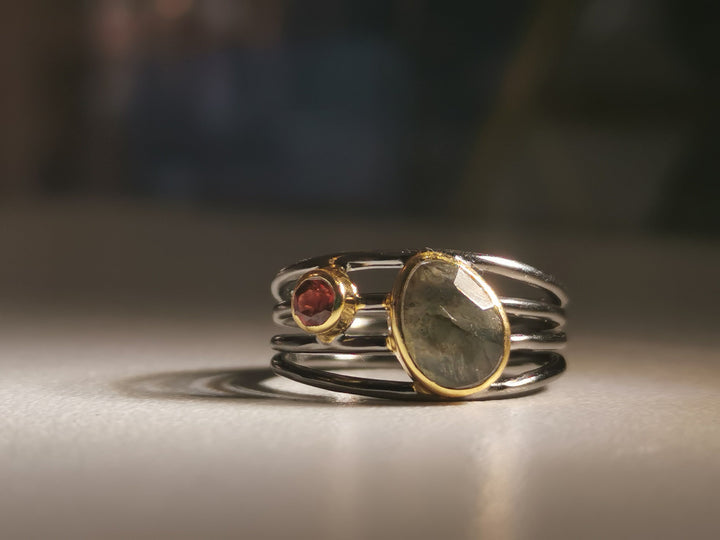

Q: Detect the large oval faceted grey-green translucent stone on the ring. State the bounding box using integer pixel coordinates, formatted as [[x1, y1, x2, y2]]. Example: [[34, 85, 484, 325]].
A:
[[399, 259, 505, 389]]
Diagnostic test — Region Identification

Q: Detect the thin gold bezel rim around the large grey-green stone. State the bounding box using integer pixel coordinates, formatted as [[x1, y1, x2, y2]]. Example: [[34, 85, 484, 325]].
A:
[[386, 251, 510, 398]]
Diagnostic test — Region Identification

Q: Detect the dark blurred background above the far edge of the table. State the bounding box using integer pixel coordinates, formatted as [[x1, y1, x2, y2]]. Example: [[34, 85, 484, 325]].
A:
[[0, 0, 720, 230]]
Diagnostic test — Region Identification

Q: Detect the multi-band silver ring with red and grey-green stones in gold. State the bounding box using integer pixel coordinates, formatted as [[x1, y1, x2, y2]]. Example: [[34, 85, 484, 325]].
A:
[[271, 249, 568, 400]]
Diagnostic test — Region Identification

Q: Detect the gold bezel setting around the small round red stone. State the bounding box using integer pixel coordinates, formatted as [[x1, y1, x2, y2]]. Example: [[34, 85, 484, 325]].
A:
[[290, 266, 361, 343]]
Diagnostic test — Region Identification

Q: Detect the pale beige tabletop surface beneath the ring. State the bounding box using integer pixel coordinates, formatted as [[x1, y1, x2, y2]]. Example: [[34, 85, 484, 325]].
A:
[[0, 205, 720, 539]]
